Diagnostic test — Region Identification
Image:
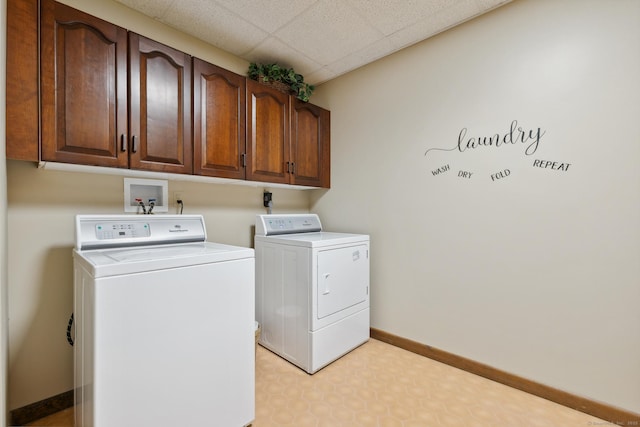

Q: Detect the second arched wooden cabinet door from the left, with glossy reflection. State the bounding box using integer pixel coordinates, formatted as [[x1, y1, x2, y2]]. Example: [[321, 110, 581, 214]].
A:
[[129, 33, 193, 174]]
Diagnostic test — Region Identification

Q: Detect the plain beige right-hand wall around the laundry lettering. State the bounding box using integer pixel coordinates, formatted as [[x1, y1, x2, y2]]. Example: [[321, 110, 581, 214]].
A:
[[311, 0, 640, 412]]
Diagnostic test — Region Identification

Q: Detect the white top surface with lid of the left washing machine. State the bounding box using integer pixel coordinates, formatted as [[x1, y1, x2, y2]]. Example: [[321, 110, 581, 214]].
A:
[[73, 242, 254, 278]]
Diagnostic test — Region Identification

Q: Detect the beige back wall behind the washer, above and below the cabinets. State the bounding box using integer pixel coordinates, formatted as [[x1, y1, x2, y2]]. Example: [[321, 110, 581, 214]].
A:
[[6, 0, 310, 410]]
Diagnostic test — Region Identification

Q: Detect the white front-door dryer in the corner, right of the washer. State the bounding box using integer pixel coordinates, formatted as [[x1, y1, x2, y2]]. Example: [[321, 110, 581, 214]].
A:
[[255, 214, 369, 374]]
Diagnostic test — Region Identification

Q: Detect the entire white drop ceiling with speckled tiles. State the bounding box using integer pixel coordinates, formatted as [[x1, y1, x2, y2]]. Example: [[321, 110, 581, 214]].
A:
[[115, 0, 512, 84]]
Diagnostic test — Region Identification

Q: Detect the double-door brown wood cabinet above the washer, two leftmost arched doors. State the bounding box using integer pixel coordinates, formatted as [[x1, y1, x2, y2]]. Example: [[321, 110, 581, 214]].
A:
[[40, 0, 192, 173]]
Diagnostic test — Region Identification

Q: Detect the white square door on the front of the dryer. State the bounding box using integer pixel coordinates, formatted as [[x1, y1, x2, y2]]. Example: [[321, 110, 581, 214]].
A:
[[317, 244, 369, 319]]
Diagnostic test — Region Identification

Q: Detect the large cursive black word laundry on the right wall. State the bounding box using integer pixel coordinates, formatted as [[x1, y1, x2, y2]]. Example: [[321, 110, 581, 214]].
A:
[[424, 120, 546, 156]]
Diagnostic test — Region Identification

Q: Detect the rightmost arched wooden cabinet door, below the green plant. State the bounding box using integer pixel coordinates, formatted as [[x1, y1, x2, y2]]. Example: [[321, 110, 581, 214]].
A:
[[291, 98, 331, 188]]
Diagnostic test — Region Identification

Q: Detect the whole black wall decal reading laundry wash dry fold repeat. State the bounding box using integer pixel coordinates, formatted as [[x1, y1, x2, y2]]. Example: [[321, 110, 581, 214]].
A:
[[424, 120, 571, 182]]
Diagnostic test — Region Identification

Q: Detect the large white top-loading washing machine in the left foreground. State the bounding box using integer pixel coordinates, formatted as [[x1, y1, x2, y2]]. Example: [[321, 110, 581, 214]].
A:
[[73, 215, 255, 427]]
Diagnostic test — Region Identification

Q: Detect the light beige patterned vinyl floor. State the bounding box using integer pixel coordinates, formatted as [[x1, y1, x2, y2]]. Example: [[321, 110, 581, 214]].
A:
[[29, 339, 613, 427]]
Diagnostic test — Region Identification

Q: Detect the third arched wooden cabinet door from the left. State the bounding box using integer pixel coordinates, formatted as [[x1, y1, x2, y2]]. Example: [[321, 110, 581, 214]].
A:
[[193, 58, 246, 179]]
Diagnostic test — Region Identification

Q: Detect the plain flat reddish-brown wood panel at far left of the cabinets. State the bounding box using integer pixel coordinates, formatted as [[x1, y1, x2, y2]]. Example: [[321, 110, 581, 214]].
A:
[[6, 0, 40, 162]]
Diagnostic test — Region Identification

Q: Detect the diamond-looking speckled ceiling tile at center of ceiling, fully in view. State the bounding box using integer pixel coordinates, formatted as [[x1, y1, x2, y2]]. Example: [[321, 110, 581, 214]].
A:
[[275, 0, 383, 65]]
